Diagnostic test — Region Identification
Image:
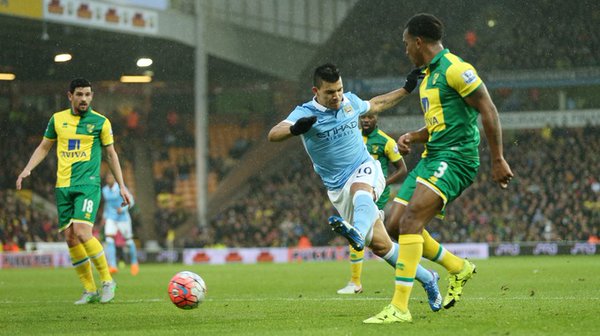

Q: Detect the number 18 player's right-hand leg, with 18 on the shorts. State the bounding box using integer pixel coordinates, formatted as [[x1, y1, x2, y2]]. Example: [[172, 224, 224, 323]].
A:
[[72, 185, 116, 303]]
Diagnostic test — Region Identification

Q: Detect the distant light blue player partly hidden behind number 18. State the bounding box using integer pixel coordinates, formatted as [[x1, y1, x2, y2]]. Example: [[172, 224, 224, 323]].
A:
[[102, 174, 140, 275]]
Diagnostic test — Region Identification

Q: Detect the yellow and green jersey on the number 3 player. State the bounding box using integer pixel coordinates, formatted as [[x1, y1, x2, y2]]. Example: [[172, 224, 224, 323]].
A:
[[419, 49, 483, 160]]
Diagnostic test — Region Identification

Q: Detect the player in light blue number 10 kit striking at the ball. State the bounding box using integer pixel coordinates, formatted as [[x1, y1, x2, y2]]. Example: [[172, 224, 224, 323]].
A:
[[269, 63, 442, 311]]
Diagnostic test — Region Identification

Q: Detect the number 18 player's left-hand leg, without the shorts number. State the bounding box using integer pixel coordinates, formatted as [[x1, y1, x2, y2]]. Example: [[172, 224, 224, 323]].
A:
[[55, 188, 99, 304]]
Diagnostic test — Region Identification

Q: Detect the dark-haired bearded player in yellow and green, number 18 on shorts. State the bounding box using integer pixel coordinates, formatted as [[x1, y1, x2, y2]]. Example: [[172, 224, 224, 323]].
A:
[[16, 78, 130, 304]]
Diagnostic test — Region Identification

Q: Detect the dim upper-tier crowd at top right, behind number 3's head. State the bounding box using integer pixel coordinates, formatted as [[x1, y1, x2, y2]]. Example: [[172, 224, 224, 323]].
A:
[[331, 0, 600, 78]]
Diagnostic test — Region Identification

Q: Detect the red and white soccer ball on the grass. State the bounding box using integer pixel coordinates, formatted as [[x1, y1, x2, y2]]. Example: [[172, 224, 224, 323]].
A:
[[169, 271, 206, 309]]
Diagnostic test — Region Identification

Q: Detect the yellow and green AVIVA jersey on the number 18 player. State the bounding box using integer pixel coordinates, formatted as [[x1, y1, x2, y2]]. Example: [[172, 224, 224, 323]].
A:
[[44, 108, 114, 188]]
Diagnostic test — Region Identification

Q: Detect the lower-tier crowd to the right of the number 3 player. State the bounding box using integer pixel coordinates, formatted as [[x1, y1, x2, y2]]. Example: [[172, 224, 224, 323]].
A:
[[438, 127, 600, 242]]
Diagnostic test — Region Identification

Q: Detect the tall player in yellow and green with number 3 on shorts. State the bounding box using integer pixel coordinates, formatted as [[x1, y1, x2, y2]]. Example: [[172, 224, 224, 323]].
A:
[[364, 14, 513, 324]]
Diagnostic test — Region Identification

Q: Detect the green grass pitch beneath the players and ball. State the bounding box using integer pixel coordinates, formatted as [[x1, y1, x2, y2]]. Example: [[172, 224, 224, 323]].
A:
[[0, 256, 600, 336]]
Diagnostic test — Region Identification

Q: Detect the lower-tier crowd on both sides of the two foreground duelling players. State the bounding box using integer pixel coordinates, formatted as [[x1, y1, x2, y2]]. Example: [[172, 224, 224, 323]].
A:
[[203, 127, 600, 246]]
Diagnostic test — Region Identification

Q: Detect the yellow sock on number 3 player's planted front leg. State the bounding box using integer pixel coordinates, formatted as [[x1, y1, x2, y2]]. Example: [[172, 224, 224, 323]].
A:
[[392, 234, 423, 312]]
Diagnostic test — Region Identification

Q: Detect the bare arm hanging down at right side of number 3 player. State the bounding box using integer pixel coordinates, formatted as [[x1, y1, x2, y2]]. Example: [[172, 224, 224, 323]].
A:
[[465, 83, 513, 188]]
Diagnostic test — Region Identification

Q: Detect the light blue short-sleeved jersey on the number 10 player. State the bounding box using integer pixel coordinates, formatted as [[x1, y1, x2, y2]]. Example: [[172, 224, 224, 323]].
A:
[[285, 92, 373, 190]]
